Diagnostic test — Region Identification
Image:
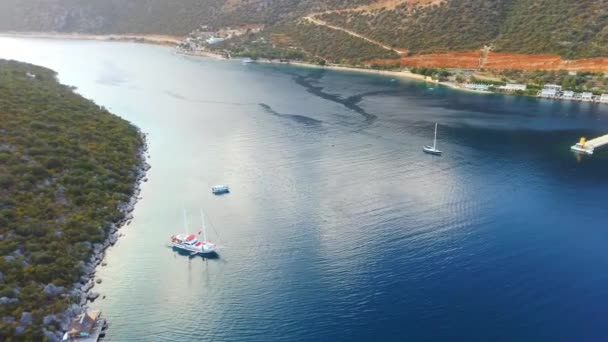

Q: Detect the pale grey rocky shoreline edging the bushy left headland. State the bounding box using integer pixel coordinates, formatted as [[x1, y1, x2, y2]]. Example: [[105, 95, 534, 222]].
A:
[[43, 131, 150, 342]]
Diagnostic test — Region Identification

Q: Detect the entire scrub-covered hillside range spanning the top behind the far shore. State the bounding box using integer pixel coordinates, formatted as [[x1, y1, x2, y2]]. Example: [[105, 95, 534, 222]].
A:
[[0, 0, 608, 59]]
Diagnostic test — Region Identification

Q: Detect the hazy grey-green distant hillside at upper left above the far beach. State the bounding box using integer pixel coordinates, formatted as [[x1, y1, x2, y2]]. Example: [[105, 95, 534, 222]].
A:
[[0, 0, 360, 35]]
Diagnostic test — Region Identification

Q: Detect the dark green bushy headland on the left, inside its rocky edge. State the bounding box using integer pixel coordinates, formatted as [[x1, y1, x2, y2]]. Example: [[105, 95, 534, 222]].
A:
[[0, 60, 143, 341]]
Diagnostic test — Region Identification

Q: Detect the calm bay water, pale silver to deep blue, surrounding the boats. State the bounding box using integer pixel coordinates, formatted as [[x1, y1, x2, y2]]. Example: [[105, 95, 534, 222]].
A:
[[0, 38, 608, 341]]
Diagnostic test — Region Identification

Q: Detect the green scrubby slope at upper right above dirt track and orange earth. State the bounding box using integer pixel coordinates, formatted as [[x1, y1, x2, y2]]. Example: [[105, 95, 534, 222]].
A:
[[319, 0, 608, 58]]
